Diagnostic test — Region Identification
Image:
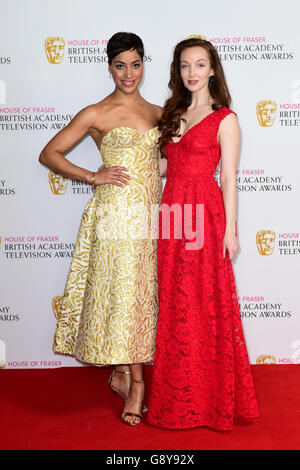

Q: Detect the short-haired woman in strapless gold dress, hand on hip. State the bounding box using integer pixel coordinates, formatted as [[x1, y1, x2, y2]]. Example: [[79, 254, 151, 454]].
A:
[[39, 33, 164, 425]]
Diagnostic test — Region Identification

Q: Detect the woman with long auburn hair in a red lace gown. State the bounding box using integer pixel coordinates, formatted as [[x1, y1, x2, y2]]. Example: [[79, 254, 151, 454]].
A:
[[148, 38, 259, 431]]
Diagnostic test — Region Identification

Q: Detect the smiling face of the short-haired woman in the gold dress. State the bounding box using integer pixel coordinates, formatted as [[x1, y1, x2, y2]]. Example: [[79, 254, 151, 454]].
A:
[[108, 49, 144, 94]]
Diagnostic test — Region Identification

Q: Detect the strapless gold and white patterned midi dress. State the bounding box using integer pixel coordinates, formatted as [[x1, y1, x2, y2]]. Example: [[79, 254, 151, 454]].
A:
[[53, 127, 161, 365]]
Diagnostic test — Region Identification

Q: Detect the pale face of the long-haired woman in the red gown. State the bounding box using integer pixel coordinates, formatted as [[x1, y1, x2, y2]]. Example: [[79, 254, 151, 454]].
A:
[[180, 46, 214, 93]]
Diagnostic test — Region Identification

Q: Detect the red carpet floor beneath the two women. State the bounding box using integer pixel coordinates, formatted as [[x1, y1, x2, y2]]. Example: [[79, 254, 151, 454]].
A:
[[0, 365, 300, 450]]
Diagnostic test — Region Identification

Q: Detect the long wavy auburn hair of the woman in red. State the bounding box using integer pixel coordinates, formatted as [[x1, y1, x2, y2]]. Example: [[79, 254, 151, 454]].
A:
[[158, 38, 231, 157]]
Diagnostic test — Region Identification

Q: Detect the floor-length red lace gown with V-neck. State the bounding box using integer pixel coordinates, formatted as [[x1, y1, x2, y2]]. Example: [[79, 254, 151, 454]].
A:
[[148, 107, 259, 431]]
